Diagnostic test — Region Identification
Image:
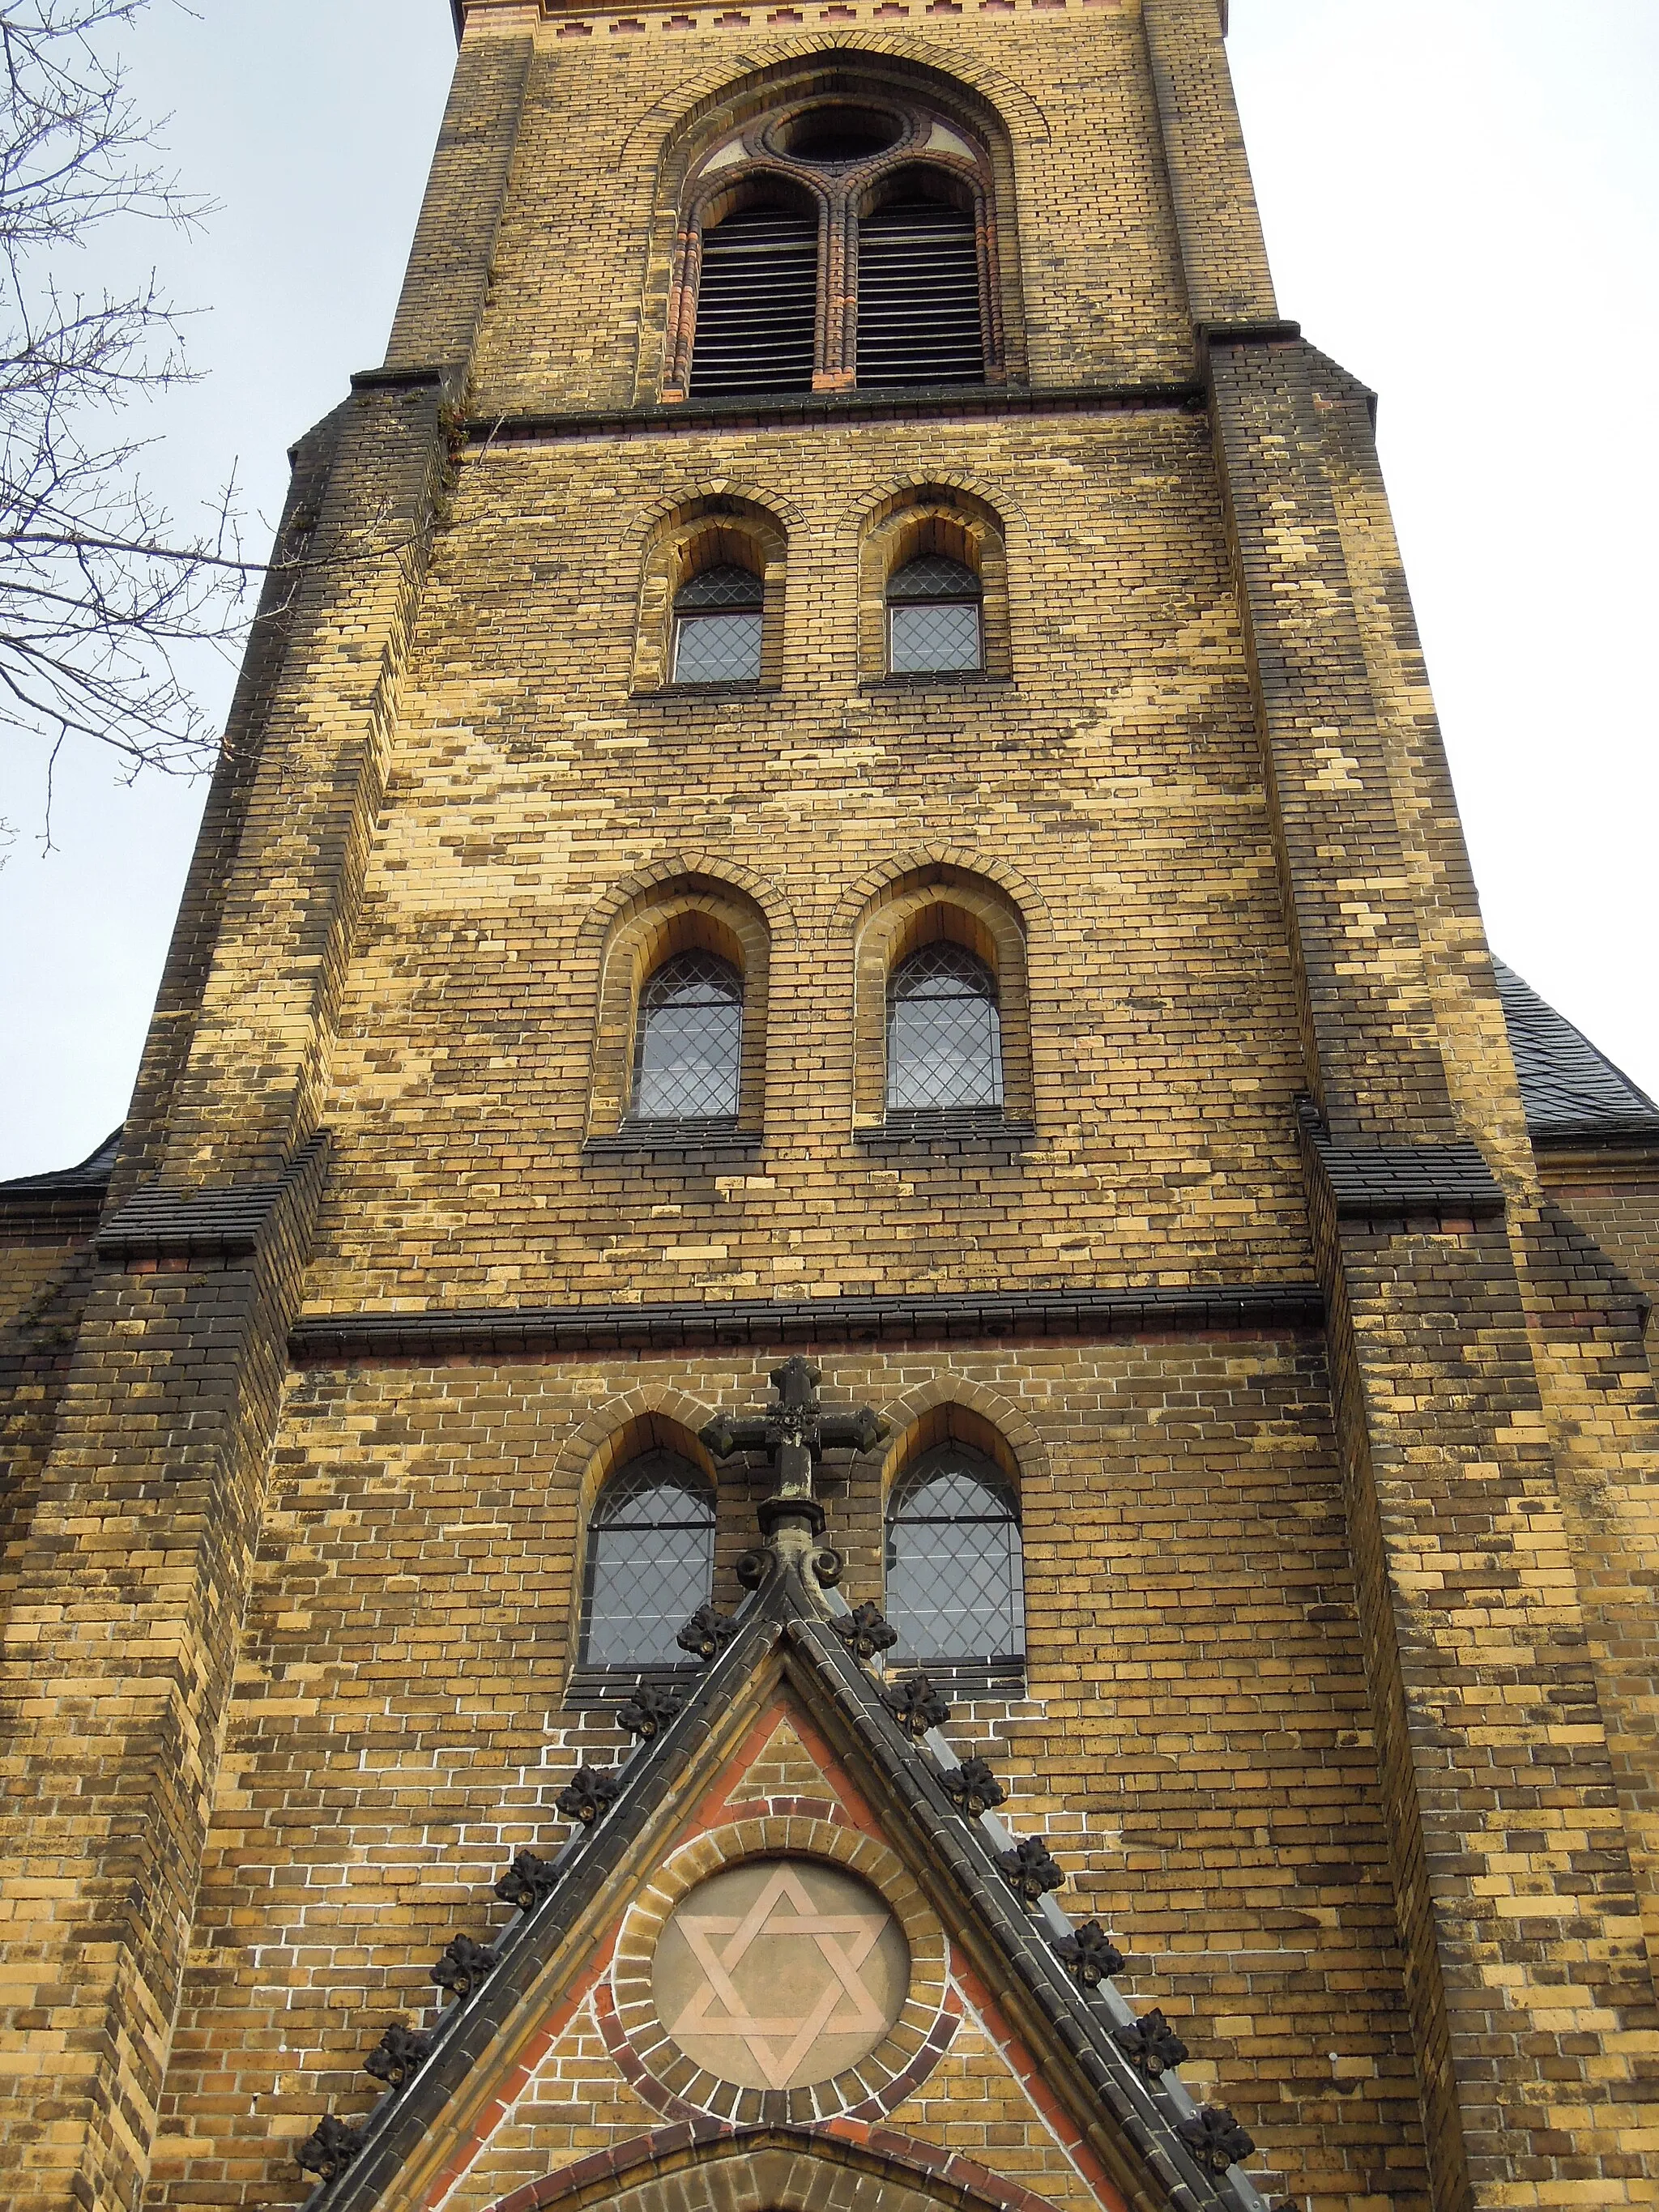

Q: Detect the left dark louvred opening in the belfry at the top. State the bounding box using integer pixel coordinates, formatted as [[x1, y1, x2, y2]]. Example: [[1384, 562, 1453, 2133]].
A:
[[690, 208, 818, 399]]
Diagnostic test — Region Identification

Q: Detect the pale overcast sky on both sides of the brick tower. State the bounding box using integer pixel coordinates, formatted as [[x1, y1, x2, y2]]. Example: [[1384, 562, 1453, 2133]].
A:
[[0, 0, 1659, 1177]]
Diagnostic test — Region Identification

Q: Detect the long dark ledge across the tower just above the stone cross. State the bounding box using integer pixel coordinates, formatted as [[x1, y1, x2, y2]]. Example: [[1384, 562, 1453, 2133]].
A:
[[288, 1283, 1325, 1367]]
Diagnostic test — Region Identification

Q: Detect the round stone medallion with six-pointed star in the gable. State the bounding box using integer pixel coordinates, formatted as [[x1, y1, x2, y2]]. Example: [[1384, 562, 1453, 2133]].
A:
[[650, 1858, 909, 2088]]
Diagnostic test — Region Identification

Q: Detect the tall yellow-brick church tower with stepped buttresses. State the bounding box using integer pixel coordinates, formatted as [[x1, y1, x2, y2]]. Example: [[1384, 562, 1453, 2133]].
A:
[[0, 0, 1659, 2212]]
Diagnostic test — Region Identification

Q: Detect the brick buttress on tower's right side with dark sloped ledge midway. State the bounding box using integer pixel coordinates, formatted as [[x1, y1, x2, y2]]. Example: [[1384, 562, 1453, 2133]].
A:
[[1210, 334, 1659, 2212]]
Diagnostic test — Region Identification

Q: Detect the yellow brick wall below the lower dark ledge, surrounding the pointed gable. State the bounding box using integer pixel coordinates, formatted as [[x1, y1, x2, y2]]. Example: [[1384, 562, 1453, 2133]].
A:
[[143, 1340, 1422, 2208]]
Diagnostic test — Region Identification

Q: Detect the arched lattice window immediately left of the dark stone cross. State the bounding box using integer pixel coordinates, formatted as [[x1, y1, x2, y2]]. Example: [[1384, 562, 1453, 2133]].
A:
[[582, 1451, 714, 1668]]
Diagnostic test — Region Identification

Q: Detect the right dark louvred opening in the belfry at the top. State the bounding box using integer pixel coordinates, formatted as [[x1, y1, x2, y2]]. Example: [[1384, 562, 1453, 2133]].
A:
[[858, 202, 984, 385]]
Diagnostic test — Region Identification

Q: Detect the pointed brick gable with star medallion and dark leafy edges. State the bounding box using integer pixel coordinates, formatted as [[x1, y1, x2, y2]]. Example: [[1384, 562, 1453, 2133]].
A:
[[296, 1566, 1260, 2212]]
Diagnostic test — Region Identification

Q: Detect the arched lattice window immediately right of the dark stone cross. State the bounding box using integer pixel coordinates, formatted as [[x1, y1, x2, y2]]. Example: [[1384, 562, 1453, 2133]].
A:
[[885, 1443, 1026, 1665]]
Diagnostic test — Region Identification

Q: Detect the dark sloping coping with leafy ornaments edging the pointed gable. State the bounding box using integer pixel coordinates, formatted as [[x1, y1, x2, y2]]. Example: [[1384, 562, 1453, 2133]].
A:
[[305, 1559, 1268, 2212]]
